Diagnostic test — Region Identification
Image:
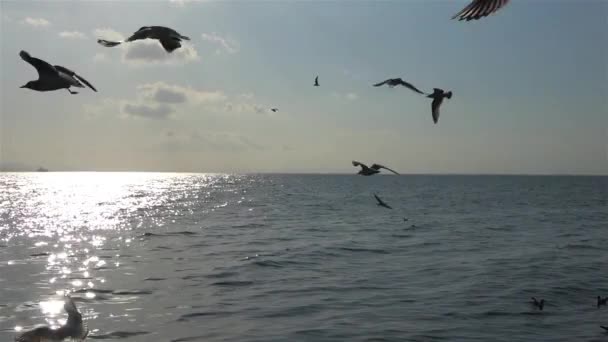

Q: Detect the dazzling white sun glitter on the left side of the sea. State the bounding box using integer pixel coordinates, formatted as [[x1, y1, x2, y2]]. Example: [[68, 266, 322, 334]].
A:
[[0, 172, 238, 332]]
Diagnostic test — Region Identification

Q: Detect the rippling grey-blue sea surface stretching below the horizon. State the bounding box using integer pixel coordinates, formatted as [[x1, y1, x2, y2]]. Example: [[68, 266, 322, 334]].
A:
[[0, 173, 608, 342]]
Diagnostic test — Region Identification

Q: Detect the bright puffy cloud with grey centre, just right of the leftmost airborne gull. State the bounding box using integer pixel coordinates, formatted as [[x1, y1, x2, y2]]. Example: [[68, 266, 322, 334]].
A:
[[137, 82, 227, 104]]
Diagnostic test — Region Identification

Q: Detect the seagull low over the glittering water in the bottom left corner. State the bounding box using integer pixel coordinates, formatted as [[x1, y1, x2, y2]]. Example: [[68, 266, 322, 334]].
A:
[[15, 296, 89, 342]]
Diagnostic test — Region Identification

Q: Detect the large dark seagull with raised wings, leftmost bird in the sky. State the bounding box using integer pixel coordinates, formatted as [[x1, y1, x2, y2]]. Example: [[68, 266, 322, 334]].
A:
[[19, 50, 97, 94]]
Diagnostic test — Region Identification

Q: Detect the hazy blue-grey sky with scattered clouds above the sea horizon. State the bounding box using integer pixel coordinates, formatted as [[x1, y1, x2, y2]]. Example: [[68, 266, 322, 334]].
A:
[[0, 0, 608, 175]]
